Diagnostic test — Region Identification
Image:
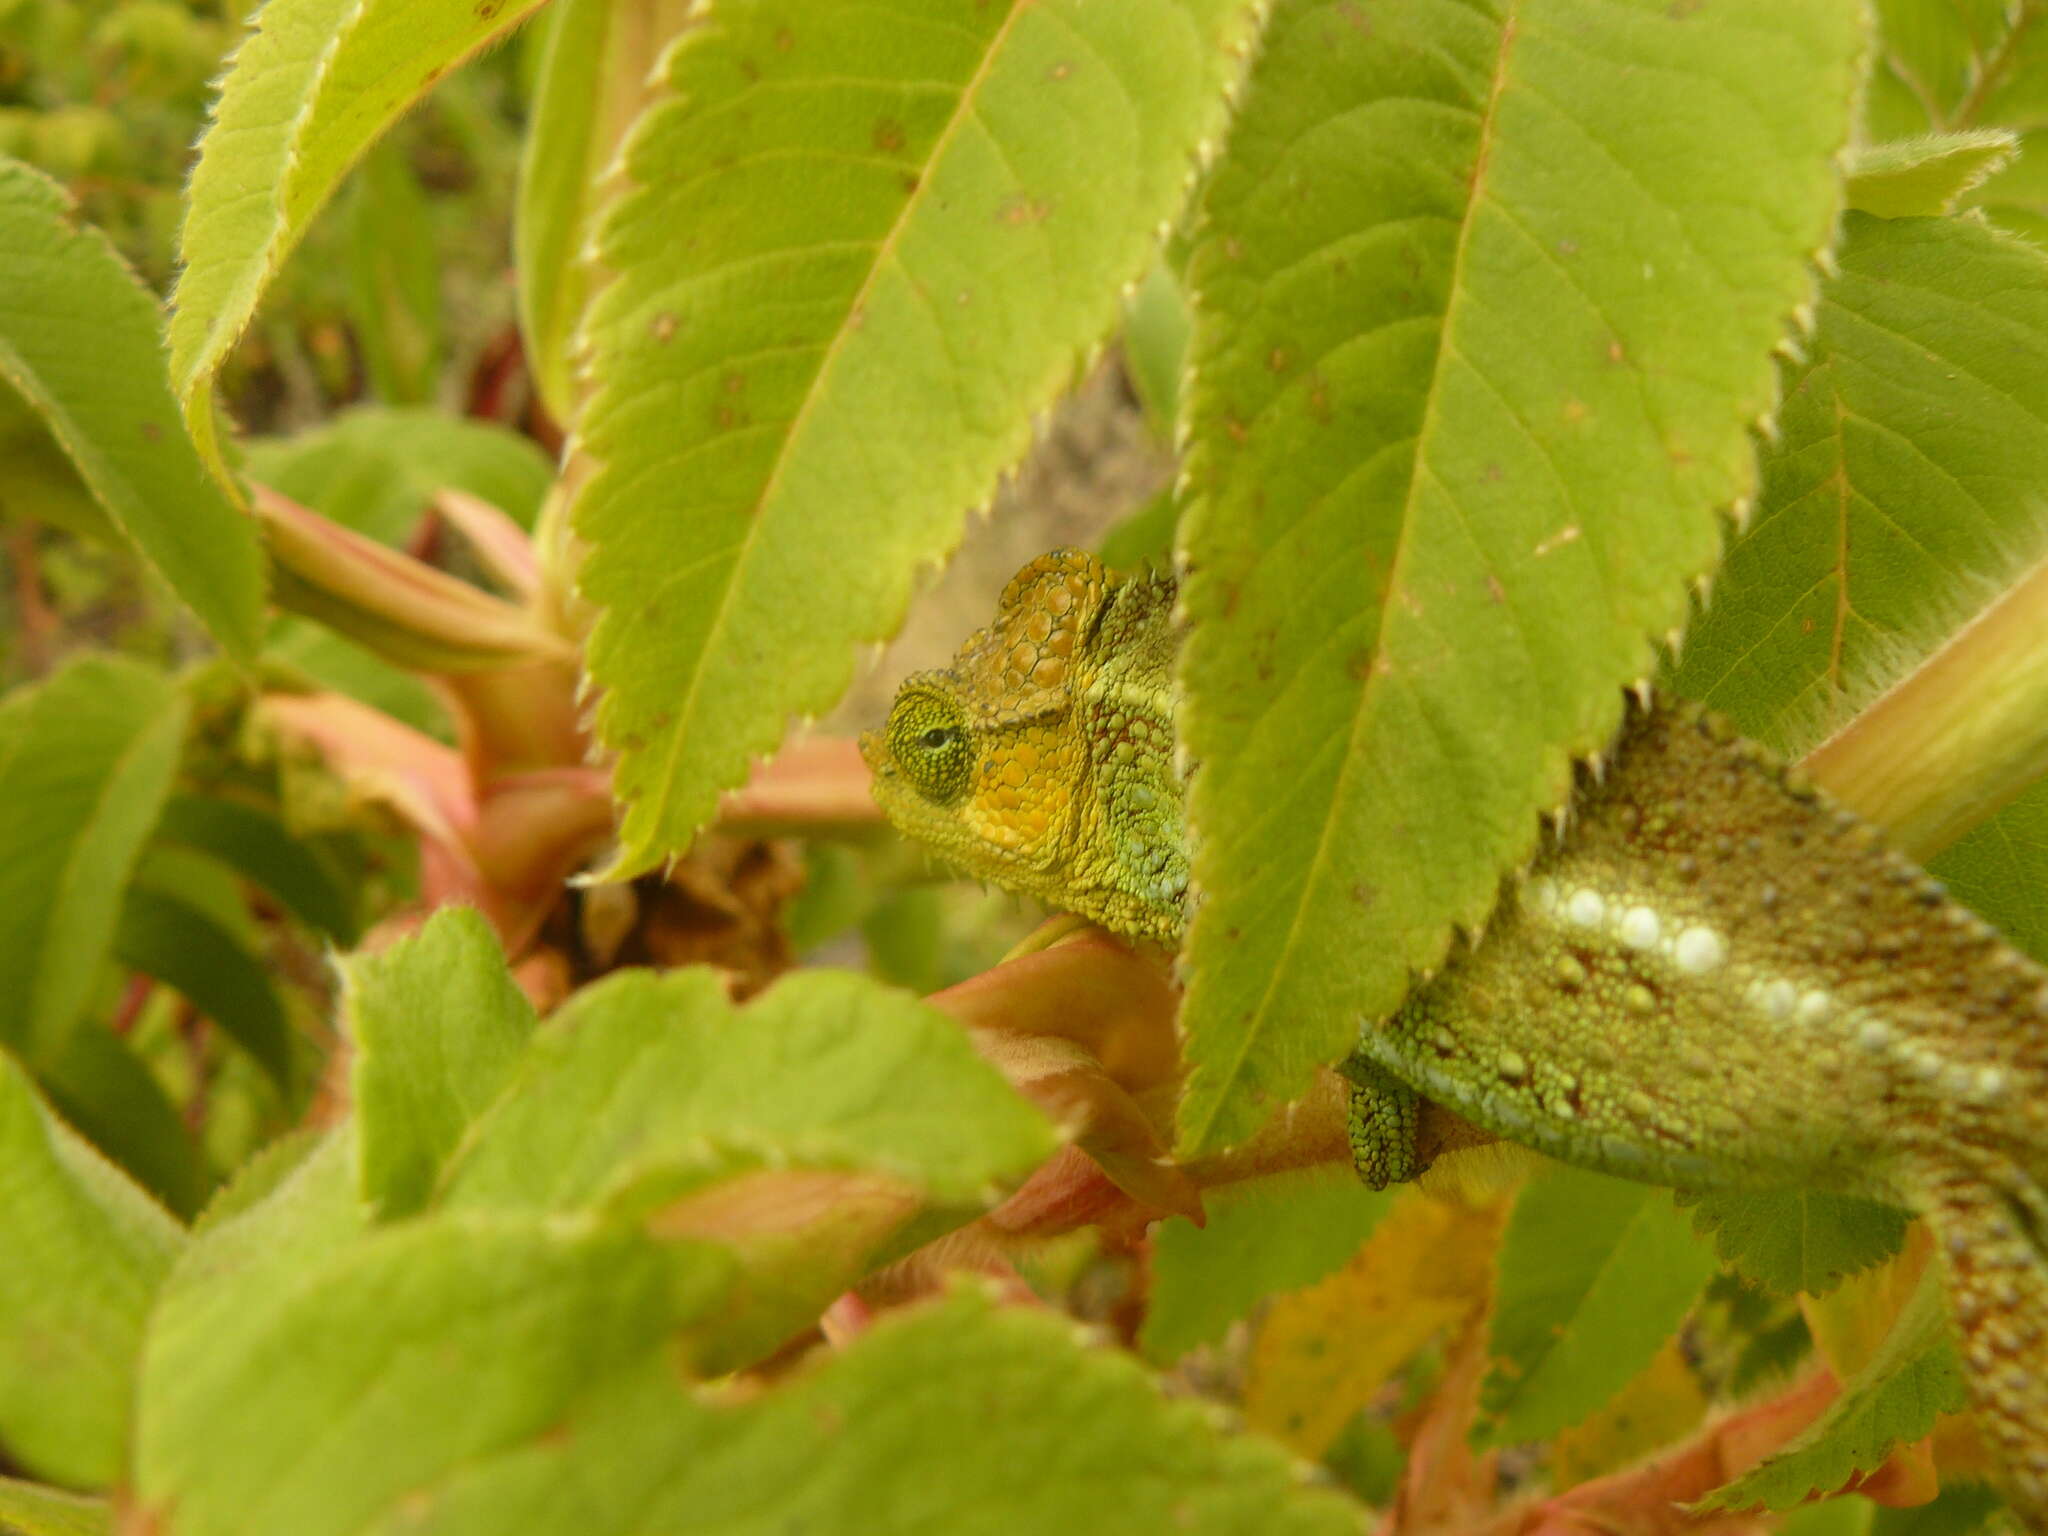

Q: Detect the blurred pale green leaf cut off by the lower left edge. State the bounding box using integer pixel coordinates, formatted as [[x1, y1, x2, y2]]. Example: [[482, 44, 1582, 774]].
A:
[[0, 1055, 184, 1499]]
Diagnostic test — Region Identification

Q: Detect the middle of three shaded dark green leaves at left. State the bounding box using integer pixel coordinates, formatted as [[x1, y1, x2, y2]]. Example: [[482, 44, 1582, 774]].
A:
[[115, 887, 293, 1094]]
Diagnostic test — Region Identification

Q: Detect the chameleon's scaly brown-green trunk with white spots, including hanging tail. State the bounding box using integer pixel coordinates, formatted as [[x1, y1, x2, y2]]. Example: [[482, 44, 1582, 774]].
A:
[[1348, 709, 2048, 1528]]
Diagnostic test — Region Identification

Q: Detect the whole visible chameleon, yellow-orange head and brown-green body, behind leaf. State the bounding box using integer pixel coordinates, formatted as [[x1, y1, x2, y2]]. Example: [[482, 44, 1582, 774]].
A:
[[862, 549, 2048, 1530]]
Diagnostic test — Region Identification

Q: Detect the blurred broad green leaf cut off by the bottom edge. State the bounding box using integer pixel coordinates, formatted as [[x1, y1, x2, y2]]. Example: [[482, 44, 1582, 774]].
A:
[[364, 1292, 1366, 1536]]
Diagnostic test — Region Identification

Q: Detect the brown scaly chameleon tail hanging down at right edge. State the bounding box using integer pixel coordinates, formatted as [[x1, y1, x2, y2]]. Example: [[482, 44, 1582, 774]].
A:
[[1915, 1161, 2048, 1534]]
